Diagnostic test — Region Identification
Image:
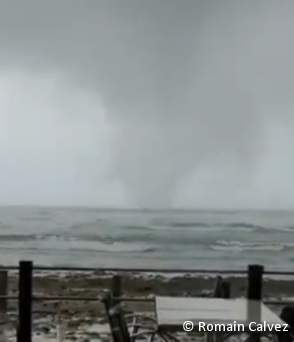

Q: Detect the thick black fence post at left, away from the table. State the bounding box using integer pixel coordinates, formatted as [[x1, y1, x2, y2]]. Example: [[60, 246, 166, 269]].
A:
[[17, 261, 33, 342]]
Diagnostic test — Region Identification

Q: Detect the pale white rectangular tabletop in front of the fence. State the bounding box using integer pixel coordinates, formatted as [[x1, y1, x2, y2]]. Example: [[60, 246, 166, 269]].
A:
[[155, 297, 284, 329]]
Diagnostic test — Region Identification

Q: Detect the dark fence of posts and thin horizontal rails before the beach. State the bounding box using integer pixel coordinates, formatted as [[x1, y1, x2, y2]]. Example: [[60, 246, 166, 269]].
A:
[[4, 261, 294, 342]]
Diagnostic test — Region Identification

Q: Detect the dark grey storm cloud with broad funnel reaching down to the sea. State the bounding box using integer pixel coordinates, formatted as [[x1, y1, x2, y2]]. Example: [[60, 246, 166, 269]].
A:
[[0, 0, 294, 206]]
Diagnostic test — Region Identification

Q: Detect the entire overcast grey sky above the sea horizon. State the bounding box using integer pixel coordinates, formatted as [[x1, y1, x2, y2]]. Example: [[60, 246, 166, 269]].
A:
[[0, 0, 294, 208]]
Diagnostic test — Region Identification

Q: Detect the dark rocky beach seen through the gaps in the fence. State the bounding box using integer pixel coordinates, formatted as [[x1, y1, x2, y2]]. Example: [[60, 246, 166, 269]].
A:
[[2, 273, 294, 341]]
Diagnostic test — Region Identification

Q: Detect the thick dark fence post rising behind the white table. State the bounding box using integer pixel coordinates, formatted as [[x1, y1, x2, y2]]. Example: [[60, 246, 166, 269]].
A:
[[247, 265, 264, 341]]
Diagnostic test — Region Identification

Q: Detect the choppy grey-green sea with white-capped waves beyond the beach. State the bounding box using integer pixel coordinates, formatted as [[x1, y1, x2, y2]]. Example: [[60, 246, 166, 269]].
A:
[[0, 207, 294, 270]]
